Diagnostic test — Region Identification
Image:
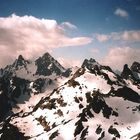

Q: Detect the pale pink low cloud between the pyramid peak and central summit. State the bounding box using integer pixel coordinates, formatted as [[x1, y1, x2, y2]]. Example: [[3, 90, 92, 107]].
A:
[[57, 57, 81, 68]]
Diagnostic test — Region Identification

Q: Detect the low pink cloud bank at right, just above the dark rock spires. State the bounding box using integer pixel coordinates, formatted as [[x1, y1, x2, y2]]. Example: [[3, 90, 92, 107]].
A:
[[101, 47, 140, 70]]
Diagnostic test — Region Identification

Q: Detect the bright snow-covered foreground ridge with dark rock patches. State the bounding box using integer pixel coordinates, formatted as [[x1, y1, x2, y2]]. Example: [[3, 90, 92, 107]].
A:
[[0, 57, 140, 140]]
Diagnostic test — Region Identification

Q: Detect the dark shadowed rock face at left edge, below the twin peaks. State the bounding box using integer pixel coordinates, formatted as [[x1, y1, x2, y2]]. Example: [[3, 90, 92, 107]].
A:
[[0, 76, 29, 121]]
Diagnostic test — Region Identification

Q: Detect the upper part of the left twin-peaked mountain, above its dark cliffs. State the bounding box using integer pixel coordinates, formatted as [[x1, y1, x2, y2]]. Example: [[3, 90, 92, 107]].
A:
[[1, 53, 70, 79]]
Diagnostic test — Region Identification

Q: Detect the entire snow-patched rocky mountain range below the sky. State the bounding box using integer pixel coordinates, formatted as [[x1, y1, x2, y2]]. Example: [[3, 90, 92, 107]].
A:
[[0, 53, 140, 140]]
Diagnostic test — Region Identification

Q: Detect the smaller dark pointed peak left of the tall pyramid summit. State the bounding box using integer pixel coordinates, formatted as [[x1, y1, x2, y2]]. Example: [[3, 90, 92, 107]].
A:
[[13, 55, 29, 69]]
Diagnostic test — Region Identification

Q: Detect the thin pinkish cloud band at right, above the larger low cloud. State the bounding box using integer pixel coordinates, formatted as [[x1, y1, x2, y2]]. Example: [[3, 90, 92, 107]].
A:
[[95, 30, 140, 42]]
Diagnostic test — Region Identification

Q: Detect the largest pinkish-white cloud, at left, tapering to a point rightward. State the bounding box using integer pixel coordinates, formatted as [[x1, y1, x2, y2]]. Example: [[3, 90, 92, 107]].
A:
[[0, 14, 92, 67]]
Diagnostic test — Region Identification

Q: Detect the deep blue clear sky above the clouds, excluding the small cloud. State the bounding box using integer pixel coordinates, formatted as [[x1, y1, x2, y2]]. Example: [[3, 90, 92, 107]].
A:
[[0, 0, 140, 34]]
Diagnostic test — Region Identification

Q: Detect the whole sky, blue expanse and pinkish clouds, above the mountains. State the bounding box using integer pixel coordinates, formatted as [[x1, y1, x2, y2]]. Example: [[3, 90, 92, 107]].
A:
[[0, 0, 140, 70]]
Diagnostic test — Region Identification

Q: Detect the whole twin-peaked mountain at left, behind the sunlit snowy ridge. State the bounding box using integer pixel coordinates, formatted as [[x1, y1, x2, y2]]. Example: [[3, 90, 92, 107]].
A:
[[0, 53, 71, 120]]
